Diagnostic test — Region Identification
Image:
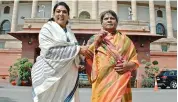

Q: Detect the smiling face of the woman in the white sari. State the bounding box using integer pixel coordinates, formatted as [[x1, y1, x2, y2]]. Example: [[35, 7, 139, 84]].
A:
[[54, 5, 69, 28]]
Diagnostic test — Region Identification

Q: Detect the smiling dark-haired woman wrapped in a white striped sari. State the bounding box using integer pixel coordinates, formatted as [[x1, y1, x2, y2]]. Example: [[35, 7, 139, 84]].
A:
[[32, 2, 85, 102]]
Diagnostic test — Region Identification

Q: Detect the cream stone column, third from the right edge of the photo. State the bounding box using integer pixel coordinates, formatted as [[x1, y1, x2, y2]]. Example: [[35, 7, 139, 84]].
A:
[[131, 0, 137, 21]]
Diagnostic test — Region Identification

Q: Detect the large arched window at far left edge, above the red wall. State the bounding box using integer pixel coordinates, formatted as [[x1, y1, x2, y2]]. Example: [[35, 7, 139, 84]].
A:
[[0, 20, 10, 34]]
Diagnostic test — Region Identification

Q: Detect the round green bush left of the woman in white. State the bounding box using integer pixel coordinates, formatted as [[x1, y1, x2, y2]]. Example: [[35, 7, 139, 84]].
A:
[[9, 58, 33, 85]]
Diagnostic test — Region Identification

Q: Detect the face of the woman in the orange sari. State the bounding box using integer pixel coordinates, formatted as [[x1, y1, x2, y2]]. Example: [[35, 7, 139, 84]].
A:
[[102, 13, 117, 32]]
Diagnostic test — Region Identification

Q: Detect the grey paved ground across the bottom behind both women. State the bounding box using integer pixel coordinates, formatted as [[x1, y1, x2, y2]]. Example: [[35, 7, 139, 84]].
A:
[[0, 81, 177, 102]]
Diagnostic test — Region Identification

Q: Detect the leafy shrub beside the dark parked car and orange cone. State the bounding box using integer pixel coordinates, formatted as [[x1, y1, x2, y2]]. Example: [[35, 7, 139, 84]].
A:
[[142, 60, 159, 87]]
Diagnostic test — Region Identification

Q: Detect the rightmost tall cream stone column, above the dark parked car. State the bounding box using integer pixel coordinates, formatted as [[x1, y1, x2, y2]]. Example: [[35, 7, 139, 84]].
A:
[[166, 0, 173, 38]]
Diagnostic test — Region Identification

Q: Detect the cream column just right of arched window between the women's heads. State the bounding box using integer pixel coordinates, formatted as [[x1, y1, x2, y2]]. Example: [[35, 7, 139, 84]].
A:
[[91, 0, 98, 19]]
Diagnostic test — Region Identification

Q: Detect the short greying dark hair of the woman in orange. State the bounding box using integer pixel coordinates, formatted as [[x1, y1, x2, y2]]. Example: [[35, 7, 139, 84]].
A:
[[100, 10, 118, 24]]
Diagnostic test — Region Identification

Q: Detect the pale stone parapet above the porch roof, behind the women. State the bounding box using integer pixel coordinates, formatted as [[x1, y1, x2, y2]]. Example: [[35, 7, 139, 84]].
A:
[[23, 18, 149, 32]]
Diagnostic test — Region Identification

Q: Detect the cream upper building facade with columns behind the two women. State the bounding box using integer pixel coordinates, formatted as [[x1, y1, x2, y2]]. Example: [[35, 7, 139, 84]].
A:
[[0, 0, 177, 38]]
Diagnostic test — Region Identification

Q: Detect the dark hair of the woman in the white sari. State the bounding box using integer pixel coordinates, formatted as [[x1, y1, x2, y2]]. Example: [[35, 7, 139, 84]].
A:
[[48, 2, 70, 21]]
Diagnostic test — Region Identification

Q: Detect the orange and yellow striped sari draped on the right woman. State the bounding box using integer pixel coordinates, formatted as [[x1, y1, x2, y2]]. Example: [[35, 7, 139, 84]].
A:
[[86, 32, 139, 102]]
